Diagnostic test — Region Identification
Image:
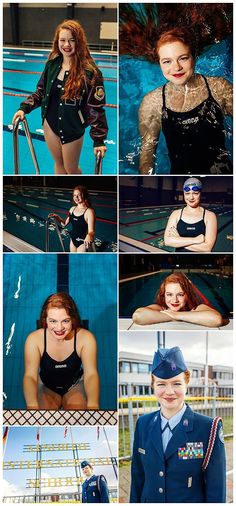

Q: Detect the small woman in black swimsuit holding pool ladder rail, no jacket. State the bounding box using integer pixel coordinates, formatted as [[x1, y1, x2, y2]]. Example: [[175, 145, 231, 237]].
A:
[[49, 186, 96, 253]]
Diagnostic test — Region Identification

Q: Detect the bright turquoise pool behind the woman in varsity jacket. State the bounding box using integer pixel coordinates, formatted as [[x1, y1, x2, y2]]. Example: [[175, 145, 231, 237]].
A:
[[3, 48, 117, 174]]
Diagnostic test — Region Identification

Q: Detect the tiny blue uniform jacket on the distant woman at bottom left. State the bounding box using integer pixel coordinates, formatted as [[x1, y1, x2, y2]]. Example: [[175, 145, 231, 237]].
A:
[[82, 474, 109, 503]]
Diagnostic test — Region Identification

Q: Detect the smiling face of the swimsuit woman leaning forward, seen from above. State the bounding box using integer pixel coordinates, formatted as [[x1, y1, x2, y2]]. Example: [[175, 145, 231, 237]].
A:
[[46, 307, 72, 340]]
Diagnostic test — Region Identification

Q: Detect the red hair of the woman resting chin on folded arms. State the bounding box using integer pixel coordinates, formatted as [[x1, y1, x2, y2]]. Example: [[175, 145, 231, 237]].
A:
[[155, 272, 202, 311]]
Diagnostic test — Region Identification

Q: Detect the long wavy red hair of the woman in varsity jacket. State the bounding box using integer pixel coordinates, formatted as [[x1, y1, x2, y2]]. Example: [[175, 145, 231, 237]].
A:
[[48, 19, 98, 99]]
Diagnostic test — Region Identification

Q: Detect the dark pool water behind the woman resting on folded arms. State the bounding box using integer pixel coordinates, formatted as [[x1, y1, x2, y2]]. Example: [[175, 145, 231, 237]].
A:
[[119, 269, 233, 318]]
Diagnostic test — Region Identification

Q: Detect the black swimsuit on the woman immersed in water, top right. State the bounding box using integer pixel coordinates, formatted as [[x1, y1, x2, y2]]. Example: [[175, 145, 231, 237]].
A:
[[162, 76, 232, 174]]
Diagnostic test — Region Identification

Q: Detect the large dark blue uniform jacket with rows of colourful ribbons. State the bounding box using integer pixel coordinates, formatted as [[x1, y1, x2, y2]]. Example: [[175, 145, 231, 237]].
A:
[[130, 406, 226, 503]]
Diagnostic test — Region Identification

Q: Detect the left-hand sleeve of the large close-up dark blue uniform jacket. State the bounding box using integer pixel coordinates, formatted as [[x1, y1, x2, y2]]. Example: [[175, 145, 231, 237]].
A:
[[130, 419, 144, 503]]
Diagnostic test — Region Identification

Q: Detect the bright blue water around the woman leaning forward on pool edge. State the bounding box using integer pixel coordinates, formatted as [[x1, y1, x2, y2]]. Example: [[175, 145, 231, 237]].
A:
[[3, 254, 117, 410]]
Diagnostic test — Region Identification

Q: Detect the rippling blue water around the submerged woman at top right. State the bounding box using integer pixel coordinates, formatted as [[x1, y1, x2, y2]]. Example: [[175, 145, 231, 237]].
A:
[[119, 38, 233, 174]]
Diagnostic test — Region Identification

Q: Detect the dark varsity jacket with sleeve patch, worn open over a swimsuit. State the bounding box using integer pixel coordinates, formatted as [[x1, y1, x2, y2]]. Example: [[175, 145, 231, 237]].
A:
[[20, 56, 108, 147]]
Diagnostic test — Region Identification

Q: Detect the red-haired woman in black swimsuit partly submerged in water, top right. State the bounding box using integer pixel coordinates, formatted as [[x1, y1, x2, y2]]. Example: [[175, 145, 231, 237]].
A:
[[139, 27, 233, 174]]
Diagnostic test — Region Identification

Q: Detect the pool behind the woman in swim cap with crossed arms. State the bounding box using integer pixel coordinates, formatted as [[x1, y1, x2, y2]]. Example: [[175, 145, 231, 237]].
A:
[[119, 204, 233, 252]]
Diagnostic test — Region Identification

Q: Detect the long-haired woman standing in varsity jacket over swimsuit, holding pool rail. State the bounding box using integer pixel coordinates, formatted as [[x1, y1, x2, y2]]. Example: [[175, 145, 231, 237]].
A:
[[12, 20, 108, 174]]
